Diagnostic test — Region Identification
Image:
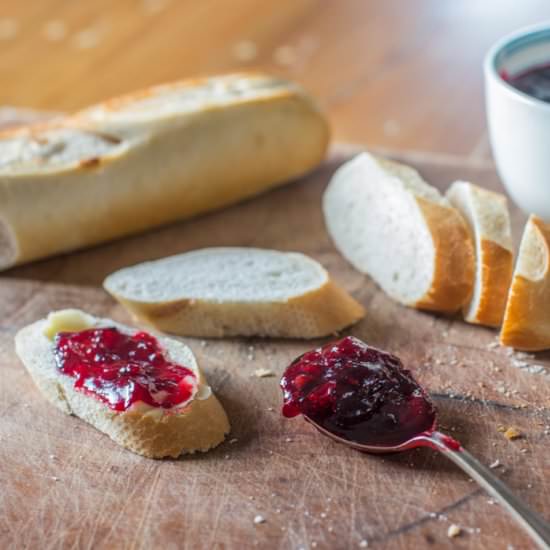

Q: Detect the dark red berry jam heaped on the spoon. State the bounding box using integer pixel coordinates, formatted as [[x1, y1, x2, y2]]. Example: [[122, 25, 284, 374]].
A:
[[281, 336, 436, 446]]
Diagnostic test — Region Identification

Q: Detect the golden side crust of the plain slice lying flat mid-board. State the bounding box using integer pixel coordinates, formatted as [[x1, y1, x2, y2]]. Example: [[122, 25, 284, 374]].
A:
[[109, 280, 365, 338]]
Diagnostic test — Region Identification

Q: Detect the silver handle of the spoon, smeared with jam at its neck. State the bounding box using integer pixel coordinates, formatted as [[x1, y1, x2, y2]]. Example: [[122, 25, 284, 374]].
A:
[[426, 432, 550, 550]]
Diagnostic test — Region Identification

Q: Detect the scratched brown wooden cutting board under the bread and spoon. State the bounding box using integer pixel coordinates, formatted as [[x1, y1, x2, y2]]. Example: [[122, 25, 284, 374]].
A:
[[0, 147, 550, 550]]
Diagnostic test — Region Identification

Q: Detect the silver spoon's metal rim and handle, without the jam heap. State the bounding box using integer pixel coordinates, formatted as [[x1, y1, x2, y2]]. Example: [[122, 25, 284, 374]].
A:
[[303, 415, 550, 550]]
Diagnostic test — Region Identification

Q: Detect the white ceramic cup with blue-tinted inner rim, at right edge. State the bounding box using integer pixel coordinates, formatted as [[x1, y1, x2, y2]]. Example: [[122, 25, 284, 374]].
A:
[[484, 21, 550, 221]]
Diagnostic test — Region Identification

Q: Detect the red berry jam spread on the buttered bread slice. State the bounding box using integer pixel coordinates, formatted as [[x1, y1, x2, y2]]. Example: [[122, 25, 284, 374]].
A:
[[55, 327, 197, 411]]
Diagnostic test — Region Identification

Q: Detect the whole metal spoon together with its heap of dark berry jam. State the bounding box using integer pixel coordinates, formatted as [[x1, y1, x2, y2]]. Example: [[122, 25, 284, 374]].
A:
[[281, 336, 550, 548]]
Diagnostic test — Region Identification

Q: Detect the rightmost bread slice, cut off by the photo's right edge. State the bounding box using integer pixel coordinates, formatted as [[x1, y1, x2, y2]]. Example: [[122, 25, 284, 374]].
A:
[[500, 215, 550, 351]]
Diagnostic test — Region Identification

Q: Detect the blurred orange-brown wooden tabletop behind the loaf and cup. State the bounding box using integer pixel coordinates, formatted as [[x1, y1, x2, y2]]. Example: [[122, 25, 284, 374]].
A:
[[0, 0, 550, 160]]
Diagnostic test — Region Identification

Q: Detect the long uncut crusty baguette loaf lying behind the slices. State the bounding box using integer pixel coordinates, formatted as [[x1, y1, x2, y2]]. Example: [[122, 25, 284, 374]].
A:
[[0, 74, 329, 269]]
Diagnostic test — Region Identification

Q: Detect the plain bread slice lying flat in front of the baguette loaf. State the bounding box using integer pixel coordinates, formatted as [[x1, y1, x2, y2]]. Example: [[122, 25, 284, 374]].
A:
[[104, 247, 364, 338]]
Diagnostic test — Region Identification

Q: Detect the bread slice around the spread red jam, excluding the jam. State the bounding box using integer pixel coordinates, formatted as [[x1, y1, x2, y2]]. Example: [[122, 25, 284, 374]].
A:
[[15, 310, 230, 458]]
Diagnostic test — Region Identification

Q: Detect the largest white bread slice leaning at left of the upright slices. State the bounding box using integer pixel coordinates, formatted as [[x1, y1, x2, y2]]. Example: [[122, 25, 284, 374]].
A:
[[323, 152, 474, 312]]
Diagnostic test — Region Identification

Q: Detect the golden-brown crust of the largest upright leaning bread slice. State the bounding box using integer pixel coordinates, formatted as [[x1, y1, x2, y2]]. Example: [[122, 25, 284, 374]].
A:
[[413, 197, 474, 313]]
